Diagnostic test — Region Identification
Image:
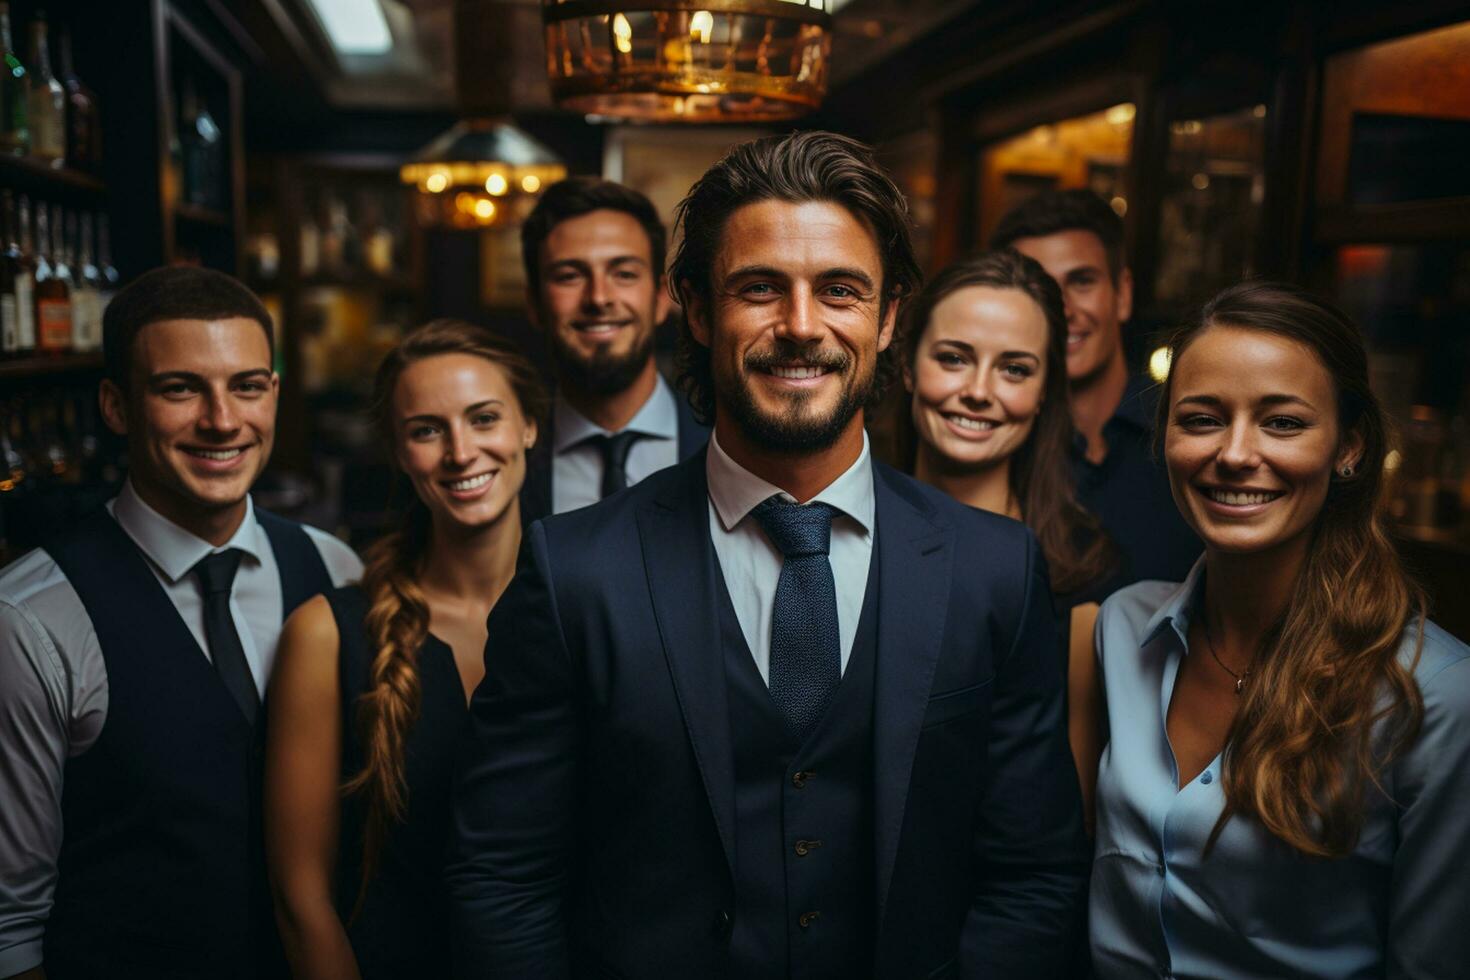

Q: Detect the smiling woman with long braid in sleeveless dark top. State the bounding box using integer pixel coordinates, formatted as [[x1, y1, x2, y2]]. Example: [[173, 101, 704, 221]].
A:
[[265, 320, 545, 980]]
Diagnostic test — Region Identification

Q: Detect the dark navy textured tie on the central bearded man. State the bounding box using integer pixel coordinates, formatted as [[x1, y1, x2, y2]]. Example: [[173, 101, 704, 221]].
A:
[[751, 497, 842, 742]]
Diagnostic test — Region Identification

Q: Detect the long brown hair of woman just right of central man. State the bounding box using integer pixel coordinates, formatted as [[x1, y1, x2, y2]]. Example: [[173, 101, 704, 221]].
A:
[[900, 248, 1114, 595]]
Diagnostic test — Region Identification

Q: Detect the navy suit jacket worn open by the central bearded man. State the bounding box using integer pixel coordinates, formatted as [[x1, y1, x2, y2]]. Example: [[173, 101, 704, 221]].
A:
[[447, 453, 1089, 980]]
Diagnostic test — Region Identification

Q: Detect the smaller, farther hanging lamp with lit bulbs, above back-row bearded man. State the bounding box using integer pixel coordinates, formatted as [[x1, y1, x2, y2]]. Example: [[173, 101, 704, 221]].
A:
[[398, 119, 566, 228]]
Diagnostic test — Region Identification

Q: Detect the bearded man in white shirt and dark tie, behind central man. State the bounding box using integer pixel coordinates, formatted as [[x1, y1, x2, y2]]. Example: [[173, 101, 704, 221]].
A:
[[520, 176, 709, 525]]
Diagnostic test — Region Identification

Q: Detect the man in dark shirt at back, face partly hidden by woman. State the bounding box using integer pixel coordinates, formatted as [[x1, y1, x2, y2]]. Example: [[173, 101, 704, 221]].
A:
[[991, 191, 1201, 598]]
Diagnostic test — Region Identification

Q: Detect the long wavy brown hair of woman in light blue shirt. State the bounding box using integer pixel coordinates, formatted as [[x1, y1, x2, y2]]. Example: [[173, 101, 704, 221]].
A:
[[1157, 281, 1424, 858]]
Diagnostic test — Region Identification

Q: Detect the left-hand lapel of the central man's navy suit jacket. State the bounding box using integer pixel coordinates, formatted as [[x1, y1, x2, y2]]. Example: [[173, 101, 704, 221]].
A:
[[638, 453, 735, 871]]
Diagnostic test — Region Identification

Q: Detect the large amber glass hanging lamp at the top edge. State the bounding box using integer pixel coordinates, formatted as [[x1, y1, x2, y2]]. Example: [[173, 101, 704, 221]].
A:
[[541, 0, 832, 122]]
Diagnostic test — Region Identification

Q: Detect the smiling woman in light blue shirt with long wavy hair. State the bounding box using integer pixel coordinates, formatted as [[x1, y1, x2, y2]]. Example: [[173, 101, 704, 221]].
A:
[[1091, 282, 1470, 980]]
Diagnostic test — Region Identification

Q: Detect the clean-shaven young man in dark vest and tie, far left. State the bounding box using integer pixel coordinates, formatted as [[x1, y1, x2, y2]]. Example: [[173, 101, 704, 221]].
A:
[[0, 267, 362, 980]]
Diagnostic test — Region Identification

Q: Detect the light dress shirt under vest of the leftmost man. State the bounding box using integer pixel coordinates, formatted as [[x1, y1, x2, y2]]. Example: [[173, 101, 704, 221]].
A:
[[0, 483, 362, 977]]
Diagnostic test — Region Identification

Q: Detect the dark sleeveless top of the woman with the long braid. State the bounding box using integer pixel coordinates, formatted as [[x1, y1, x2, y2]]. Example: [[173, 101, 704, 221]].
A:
[[326, 586, 469, 980]]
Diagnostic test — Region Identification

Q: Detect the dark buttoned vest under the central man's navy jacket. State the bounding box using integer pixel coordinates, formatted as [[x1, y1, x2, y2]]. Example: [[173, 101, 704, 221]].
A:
[[719, 548, 879, 980]]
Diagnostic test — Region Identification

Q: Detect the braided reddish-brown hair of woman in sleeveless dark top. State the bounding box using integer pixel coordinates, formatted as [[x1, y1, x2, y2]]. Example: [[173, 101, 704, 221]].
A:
[[343, 320, 547, 915]]
